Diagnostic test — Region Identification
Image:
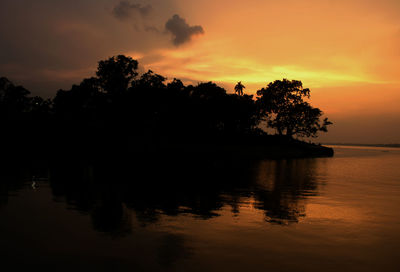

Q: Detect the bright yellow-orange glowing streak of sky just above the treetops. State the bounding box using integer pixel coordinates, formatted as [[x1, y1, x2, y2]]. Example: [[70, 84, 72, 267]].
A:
[[136, 47, 389, 88]]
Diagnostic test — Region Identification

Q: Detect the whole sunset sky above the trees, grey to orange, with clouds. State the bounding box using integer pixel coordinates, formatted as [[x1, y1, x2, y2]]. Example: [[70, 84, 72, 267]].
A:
[[0, 0, 400, 143]]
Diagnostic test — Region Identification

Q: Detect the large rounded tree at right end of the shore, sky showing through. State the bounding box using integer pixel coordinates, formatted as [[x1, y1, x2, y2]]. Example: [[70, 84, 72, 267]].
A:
[[257, 79, 332, 137]]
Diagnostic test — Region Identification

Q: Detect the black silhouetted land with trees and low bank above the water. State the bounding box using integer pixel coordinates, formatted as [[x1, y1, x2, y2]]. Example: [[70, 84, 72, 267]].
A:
[[0, 55, 333, 161]]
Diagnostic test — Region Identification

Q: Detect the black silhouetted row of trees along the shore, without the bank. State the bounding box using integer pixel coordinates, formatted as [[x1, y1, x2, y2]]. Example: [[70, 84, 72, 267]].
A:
[[0, 55, 331, 155]]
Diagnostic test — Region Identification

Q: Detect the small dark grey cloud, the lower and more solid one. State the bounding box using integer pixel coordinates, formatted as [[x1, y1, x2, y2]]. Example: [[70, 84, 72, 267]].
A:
[[165, 14, 204, 46]]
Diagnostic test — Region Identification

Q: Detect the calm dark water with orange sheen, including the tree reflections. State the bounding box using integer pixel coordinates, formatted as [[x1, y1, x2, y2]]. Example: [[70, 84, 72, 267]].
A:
[[0, 147, 400, 271]]
